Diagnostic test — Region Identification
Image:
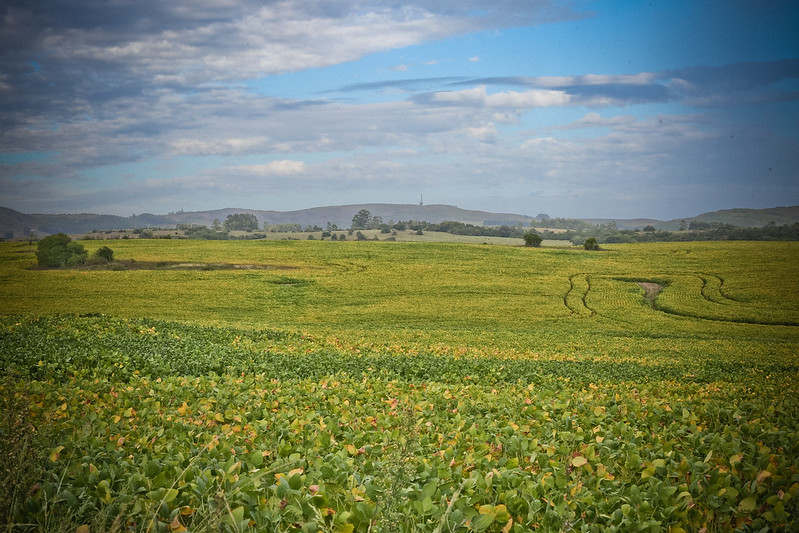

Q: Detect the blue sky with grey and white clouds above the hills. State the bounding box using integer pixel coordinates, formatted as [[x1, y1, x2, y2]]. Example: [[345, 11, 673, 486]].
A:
[[0, 0, 799, 220]]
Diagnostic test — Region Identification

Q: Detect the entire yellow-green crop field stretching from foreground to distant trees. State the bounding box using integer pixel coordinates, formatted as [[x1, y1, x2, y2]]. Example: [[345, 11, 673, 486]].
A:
[[0, 239, 799, 533]]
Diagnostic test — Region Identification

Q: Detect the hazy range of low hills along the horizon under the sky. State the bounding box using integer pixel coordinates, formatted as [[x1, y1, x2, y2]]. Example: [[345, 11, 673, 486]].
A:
[[0, 204, 799, 239]]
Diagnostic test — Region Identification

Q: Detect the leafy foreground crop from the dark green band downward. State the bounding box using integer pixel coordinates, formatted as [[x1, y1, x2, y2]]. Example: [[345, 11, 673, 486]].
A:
[[0, 317, 799, 532]]
